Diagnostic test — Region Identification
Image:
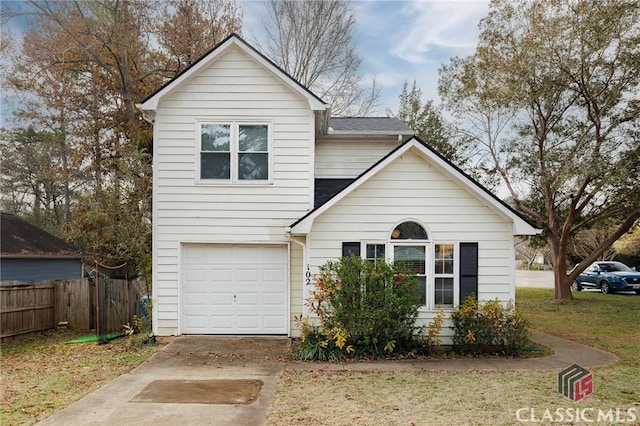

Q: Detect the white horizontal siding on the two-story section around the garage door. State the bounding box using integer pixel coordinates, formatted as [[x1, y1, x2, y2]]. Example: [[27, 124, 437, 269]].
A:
[[153, 47, 315, 335]]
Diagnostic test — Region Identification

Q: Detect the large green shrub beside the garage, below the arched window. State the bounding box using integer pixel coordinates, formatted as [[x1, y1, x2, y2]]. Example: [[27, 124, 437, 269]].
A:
[[298, 256, 440, 360]]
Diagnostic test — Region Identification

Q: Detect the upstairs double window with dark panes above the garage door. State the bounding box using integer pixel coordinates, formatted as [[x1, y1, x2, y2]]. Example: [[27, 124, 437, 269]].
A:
[[199, 122, 271, 182]]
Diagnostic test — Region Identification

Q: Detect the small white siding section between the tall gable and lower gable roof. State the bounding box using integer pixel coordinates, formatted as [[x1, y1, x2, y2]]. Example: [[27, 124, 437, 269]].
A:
[[315, 138, 398, 179]]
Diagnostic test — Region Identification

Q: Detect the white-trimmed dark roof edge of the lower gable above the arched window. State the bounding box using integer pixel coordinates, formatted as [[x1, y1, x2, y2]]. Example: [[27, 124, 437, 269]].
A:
[[289, 137, 540, 235]]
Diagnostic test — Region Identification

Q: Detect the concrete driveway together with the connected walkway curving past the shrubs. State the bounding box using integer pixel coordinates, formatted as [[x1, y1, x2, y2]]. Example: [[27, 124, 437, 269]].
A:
[[39, 333, 617, 426]]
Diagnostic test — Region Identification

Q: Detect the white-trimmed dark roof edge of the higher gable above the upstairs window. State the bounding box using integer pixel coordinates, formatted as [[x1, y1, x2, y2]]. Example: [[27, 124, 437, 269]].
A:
[[138, 33, 329, 116]]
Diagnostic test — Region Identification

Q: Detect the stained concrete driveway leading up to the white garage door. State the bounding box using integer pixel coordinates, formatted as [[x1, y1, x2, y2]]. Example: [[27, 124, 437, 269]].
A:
[[38, 336, 290, 426]]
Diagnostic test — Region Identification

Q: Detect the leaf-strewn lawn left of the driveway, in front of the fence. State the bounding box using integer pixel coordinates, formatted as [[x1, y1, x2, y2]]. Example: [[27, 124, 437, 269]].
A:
[[0, 330, 158, 425]]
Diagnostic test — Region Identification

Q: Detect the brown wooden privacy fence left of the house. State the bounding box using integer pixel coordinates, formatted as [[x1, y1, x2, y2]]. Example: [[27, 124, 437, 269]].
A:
[[0, 277, 144, 337]]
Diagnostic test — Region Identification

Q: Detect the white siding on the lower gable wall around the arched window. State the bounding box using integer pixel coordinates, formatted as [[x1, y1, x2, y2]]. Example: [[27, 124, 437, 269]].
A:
[[310, 151, 513, 342]]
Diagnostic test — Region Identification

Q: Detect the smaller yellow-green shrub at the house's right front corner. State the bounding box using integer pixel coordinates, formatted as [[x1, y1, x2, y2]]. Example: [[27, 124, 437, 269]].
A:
[[451, 296, 529, 355]]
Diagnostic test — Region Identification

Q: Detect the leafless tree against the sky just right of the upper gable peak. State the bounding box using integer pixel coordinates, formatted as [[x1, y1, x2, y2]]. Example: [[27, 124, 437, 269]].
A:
[[258, 0, 380, 116]]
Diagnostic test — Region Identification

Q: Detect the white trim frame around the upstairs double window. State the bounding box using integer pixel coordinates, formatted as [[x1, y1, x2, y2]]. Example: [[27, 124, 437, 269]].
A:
[[195, 120, 273, 186]]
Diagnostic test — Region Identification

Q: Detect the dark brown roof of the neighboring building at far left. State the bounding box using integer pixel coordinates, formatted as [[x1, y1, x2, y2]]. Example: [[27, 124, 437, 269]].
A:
[[0, 212, 82, 259]]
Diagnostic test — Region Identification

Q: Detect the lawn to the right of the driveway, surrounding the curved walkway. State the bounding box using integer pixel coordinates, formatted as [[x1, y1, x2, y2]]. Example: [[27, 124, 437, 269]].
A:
[[267, 288, 640, 425]]
